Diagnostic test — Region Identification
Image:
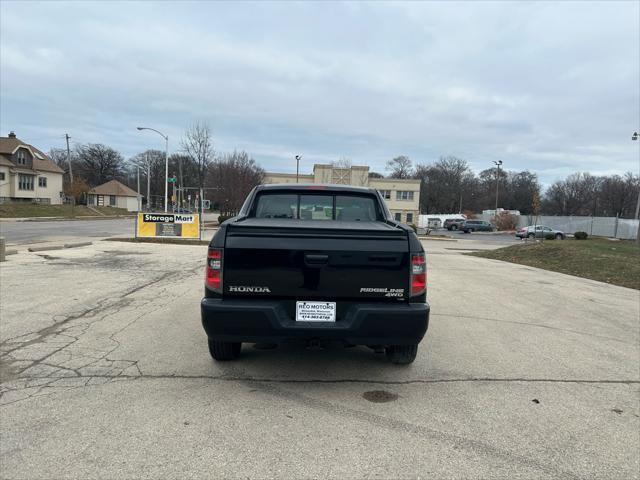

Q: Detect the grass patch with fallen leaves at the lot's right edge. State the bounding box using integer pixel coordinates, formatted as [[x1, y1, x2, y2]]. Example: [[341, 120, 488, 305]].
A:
[[466, 238, 640, 290]]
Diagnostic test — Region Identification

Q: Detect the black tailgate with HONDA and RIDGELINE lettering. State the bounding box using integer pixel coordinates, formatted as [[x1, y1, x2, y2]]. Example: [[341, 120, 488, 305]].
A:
[[223, 218, 410, 302]]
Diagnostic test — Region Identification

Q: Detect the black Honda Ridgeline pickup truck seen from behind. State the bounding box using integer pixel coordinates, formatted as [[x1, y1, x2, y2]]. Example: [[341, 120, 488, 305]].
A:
[[201, 184, 429, 364]]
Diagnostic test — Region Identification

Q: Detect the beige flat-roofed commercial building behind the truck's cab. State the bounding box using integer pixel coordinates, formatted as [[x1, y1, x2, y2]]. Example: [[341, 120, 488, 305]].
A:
[[264, 164, 420, 225]]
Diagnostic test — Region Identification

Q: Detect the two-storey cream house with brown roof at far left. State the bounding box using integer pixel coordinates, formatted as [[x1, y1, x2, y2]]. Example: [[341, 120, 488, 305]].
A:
[[0, 132, 64, 205]]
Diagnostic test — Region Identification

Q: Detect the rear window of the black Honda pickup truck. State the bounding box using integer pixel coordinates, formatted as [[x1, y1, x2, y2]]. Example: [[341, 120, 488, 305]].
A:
[[253, 193, 380, 222]]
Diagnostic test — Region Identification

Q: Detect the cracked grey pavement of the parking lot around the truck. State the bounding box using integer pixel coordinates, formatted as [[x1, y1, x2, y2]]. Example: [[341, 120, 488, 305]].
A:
[[0, 236, 640, 479]]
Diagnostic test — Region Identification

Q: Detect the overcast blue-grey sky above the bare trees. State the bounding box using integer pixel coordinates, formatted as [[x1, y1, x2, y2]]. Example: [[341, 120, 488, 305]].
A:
[[0, 1, 640, 184]]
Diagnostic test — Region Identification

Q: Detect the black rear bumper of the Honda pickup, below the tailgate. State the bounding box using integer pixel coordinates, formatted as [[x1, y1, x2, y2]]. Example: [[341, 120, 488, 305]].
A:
[[201, 298, 430, 345]]
